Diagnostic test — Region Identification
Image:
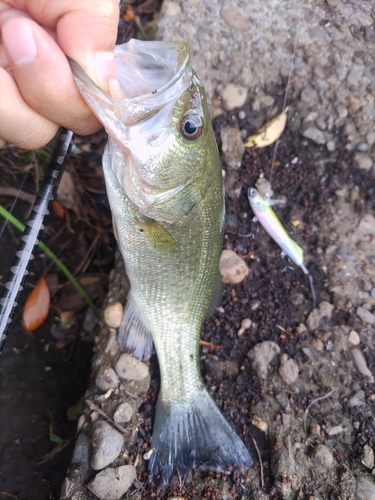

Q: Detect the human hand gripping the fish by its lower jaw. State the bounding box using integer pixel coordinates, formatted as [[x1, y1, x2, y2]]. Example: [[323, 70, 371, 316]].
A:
[[0, 0, 119, 149]]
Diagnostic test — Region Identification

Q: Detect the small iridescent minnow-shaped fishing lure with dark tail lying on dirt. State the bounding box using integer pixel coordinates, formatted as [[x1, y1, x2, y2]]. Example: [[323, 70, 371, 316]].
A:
[[247, 187, 317, 307]]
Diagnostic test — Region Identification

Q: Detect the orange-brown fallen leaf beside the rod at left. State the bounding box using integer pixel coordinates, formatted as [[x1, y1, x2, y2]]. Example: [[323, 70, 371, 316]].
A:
[[22, 276, 50, 331]]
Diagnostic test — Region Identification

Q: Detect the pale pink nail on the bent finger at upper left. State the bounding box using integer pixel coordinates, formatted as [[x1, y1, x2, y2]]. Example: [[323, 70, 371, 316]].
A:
[[2, 19, 37, 65]]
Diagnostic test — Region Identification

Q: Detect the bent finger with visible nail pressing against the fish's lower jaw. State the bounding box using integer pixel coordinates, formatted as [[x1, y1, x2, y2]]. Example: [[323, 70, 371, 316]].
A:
[[0, 18, 100, 138]]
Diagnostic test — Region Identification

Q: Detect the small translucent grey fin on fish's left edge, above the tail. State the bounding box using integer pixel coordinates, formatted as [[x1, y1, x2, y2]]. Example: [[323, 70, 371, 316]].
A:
[[118, 297, 152, 361]]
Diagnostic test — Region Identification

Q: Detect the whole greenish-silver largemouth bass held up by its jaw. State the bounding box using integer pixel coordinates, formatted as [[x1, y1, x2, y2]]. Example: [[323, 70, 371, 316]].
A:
[[72, 40, 253, 487]]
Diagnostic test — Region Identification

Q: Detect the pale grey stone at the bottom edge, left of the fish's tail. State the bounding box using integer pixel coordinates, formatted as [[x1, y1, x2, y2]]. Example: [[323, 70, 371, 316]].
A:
[[88, 465, 136, 500]]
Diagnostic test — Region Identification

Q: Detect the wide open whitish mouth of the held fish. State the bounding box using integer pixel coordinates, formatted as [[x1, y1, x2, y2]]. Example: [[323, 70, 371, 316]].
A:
[[70, 39, 192, 132]]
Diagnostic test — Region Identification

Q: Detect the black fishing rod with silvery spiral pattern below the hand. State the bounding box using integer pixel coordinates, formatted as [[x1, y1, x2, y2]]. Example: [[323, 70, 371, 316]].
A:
[[0, 127, 73, 353]]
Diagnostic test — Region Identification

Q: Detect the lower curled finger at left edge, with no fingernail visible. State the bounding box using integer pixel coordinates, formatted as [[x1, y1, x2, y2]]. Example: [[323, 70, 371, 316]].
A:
[[0, 68, 58, 149]]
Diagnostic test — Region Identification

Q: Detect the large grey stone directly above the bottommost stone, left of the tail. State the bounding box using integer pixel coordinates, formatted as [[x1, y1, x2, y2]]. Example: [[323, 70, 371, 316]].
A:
[[91, 420, 123, 470]]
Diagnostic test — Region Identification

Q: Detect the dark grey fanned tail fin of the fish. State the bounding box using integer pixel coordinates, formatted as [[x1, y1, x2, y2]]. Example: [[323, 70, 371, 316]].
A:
[[149, 388, 253, 488]]
